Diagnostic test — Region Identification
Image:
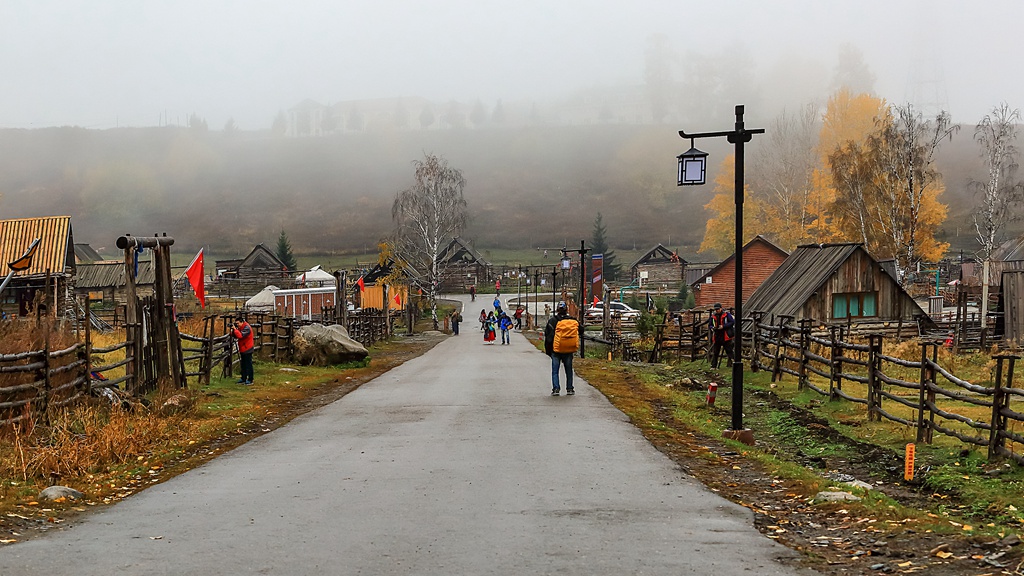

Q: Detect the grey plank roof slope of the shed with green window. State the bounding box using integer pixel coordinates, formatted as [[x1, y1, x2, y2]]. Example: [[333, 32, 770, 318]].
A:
[[743, 243, 873, 316]]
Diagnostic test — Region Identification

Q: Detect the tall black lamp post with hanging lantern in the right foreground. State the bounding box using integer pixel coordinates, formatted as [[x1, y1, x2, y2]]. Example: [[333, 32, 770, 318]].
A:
[[677, 106, 765, 445]]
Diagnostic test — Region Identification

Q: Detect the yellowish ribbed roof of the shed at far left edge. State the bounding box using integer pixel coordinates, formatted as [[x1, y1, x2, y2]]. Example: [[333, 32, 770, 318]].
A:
[[0, 216, 75, 278]]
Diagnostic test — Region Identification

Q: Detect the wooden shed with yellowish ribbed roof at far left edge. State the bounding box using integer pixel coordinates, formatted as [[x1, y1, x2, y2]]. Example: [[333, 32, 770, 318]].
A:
[[0, 216, 75, 316]]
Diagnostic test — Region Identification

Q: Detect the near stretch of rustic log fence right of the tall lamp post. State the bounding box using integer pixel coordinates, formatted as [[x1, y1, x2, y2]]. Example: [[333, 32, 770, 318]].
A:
[[743, 311, 1024, 464]]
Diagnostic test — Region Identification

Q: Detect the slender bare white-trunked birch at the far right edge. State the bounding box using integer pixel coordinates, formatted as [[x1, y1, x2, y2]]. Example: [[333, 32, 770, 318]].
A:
[[970, 102, 1022, 318]]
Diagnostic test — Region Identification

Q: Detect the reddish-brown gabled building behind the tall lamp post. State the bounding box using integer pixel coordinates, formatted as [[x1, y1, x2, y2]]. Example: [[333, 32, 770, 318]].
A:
[[690, 235, 790, 308]]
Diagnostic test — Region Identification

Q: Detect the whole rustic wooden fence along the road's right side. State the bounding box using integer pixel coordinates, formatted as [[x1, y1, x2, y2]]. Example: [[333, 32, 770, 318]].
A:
[[588, 312, 1024, 464]]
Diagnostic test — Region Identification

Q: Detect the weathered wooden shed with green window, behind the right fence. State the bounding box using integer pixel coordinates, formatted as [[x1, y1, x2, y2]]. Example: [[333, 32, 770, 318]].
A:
[[743, 243, 925, 323]]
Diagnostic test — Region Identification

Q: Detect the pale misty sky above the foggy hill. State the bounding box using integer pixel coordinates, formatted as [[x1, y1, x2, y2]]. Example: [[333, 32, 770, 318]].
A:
[[0, 0, 1024, 129]]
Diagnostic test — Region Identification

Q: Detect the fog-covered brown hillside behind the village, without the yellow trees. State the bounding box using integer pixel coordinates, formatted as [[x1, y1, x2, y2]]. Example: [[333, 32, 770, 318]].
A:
[[0, 124, 1007, 260]]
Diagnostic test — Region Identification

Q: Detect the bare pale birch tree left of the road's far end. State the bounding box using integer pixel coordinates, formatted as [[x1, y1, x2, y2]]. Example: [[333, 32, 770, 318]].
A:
[[391, 155, 467, 330]]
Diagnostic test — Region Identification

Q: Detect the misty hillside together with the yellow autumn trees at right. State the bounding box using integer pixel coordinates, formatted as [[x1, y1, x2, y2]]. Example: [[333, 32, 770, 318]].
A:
[[0, 91, 1019, 260]]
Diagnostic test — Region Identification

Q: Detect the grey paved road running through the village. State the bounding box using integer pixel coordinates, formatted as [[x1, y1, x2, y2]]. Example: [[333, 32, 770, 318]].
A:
[[0, 297, 808, 576]]
